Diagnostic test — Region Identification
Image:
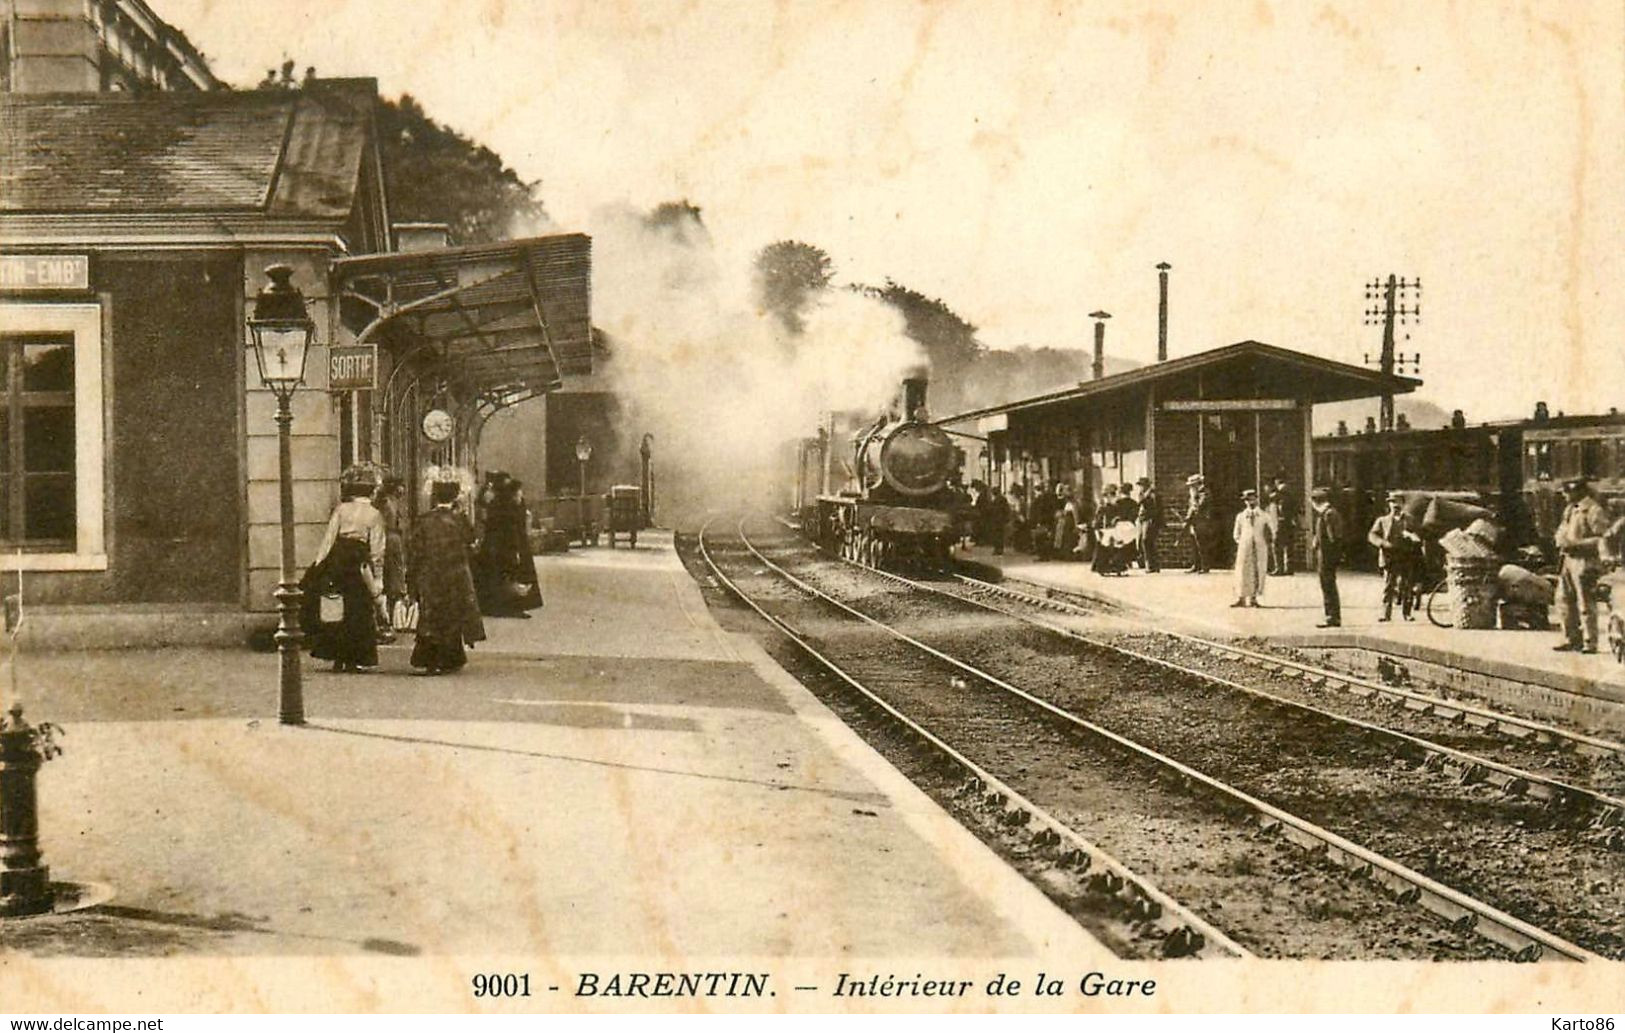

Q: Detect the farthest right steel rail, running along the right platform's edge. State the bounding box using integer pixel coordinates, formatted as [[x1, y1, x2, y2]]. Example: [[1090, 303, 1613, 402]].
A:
[[949, 560, 1625, 757]]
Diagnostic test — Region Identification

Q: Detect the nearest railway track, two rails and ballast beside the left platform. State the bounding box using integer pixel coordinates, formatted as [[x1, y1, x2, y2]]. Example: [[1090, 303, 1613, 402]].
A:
[[702, 528, 1594, 960]]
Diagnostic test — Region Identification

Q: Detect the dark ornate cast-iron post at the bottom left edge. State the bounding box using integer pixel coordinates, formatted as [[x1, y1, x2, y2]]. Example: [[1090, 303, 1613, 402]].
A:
[[0, 703, 62, 918]]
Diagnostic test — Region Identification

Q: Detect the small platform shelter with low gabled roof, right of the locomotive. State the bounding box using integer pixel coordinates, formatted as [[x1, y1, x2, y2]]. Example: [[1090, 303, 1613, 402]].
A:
[[939, 341, 1422, 562]]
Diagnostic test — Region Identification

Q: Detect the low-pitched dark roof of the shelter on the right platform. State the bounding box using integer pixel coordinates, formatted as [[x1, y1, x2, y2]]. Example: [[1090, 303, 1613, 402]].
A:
[[936, 341, 1422, 424]]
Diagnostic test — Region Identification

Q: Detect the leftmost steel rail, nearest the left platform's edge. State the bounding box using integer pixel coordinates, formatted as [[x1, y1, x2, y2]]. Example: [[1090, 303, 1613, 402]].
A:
[[697, 520, 1255, 958]]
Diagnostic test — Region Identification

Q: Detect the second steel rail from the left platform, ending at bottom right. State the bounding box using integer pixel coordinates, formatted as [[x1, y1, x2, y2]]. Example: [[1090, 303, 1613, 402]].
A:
[[741, 519, 1604, 962]]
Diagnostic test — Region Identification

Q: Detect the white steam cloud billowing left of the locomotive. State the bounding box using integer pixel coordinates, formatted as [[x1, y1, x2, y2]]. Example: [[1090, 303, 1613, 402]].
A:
[[592, 210, 923, 526]]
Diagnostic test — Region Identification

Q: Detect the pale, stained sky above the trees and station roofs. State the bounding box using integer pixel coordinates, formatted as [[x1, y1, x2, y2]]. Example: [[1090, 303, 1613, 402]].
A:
[[151, 0, 1625, 419]]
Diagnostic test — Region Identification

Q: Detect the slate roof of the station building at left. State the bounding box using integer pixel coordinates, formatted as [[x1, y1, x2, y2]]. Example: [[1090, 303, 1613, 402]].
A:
[[0, 80, 377, 219]]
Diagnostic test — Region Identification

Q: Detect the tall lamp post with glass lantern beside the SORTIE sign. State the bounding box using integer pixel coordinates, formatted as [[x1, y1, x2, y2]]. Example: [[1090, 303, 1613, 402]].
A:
[[249, 265, 315, 724]]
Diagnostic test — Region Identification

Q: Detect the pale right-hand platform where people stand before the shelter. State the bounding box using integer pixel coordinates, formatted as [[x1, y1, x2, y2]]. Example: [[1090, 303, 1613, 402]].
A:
[[956, 546, 1625, 734]]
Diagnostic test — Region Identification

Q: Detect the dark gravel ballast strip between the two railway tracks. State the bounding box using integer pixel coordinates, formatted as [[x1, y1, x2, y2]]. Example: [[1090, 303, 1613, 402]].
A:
[[754, 532, 1625, 957]]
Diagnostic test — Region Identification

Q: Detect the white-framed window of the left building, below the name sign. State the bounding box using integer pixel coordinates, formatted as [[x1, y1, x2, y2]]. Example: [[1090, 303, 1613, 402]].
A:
[[0, 304, 107, 570]]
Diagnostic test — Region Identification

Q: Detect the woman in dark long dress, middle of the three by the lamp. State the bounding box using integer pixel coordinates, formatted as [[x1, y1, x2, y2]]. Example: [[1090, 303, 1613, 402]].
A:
[[406, 482, 486, 674]]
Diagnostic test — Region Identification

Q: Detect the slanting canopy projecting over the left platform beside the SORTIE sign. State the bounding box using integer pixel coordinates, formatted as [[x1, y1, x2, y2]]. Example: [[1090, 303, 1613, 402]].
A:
[[333, 234, 593, 404]]
